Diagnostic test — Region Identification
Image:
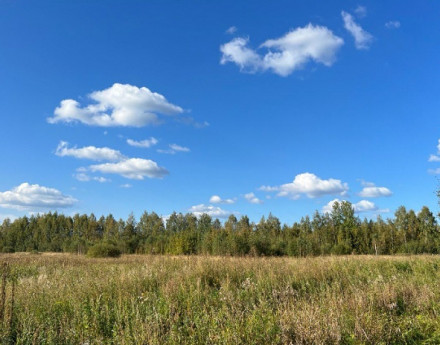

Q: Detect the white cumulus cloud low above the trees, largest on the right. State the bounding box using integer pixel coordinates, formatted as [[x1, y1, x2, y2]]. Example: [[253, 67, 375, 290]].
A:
[[260, 172, 348, 199]]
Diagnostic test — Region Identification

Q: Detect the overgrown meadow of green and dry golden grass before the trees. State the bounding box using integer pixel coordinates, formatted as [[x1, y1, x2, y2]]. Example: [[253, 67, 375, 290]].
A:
[[0, 254, 440, 344]]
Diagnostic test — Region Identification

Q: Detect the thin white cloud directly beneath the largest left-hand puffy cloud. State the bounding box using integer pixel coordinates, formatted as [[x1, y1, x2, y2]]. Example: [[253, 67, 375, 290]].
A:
[[55, 141, 126, 161]]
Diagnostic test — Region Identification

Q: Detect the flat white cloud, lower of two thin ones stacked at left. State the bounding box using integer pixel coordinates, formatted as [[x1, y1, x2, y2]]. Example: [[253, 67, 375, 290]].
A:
[[88, 158, 168, 180]]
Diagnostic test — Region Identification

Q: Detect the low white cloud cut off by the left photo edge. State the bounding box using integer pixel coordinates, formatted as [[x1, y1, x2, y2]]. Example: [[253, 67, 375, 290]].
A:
[[0, 182, 77, 210]]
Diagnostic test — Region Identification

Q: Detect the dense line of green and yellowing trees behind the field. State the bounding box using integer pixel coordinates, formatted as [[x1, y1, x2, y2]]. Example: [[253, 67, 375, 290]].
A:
[[0, 202, 440, 256]]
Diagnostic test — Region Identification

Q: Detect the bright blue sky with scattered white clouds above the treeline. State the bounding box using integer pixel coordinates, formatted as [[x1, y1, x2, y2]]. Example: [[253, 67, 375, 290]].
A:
[[0, 0, 440, 223]]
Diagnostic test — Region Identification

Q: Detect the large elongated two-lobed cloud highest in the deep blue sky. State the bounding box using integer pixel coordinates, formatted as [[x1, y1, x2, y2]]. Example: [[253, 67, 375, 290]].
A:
[[220, 24, 344, 77]]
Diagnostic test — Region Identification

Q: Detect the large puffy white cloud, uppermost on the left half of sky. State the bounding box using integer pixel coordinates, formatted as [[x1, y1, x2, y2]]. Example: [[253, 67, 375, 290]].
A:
[[47, 83, 183, 127]]
